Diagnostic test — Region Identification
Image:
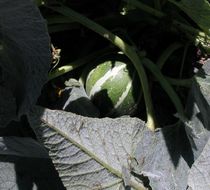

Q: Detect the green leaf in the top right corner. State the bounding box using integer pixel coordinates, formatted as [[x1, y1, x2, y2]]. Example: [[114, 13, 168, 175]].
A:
[[169, 0, 210, 34]]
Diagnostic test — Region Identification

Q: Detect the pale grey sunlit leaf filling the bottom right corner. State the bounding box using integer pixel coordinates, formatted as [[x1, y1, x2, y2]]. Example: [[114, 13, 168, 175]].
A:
[[188, 139, 210, 190]]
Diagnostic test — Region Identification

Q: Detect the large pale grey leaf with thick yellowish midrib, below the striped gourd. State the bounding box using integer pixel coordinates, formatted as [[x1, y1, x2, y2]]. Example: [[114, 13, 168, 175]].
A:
[[29, 107, 193, 190]]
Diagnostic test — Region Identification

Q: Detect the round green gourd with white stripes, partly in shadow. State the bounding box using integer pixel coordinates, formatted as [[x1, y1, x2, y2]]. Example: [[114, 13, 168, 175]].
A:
[[85, 56, 140, 117]]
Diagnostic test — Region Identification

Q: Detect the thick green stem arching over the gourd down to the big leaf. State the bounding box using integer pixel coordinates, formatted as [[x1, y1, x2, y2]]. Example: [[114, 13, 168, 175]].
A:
[[49, 6, 157, 130]]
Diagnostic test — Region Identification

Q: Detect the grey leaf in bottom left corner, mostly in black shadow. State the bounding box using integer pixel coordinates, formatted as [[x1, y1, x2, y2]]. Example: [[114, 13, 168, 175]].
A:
[[0, 137, 65, 190]]
